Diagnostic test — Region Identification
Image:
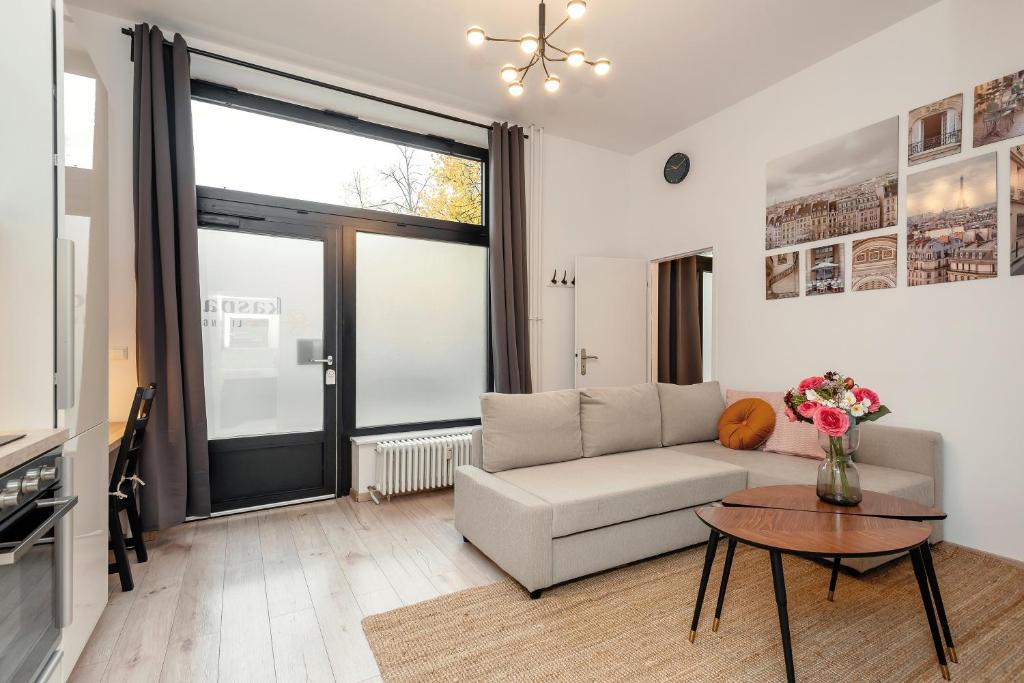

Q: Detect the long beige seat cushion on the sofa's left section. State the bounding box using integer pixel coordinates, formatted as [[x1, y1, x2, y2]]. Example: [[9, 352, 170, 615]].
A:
[[495, 449, 746, 538]]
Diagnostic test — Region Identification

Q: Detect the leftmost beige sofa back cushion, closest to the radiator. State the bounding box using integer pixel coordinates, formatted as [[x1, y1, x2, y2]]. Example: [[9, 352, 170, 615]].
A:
[[480, 389, 583, 472]]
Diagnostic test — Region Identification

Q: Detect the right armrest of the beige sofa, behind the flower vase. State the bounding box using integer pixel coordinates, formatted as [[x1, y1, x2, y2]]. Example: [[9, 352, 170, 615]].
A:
[[854, 423, 943, 528]]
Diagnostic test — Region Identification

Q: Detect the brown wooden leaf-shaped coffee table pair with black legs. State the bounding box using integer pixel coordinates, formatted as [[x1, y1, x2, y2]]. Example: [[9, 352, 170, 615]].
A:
[[690, 486, 956, 681]]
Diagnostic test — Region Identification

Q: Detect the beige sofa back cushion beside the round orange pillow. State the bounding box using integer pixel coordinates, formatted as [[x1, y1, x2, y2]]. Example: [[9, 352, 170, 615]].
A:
[[657, 382, 725, 445]]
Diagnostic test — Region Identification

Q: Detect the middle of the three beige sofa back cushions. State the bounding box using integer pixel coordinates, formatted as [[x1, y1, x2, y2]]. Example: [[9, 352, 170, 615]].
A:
[[580, 384, 662, 458]]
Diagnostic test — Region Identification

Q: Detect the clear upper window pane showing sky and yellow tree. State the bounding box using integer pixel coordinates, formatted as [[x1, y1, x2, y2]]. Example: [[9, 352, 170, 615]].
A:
[[193, 100, 483, 225]]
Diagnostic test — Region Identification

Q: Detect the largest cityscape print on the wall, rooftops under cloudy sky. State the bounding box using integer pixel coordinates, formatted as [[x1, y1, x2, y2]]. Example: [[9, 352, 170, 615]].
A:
[[765, 117, 899, 249]]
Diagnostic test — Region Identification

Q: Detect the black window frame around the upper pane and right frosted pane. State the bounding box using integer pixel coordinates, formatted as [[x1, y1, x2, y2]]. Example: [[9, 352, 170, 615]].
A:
[[191, 79, 494, 494]]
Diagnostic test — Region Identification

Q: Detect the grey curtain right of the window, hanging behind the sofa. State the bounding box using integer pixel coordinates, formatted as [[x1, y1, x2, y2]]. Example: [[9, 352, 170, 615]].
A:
[[488, 123, 532, 393]]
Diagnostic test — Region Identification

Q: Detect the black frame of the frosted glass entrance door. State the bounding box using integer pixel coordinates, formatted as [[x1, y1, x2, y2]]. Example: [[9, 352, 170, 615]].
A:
[[198, 214, 339, 514]]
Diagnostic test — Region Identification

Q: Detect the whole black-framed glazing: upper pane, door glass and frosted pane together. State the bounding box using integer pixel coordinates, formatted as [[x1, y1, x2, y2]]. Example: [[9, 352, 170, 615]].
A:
[[193, 81, 490, 444]]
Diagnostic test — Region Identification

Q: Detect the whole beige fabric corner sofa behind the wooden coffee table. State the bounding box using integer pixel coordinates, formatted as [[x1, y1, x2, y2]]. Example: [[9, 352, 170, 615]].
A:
[[455, 382, 942, 597]]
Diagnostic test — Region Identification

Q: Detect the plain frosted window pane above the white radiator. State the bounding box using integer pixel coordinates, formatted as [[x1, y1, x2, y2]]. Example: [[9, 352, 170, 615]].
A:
[[355, 232, 487, 428]]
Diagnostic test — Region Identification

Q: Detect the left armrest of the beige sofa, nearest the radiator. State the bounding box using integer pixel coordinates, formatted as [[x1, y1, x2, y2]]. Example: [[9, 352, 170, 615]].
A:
[[455, 465, 553, 591]]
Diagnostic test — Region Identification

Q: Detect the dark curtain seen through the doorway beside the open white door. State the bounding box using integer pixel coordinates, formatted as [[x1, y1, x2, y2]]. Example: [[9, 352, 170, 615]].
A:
[[657, 256, 703, 384]]
